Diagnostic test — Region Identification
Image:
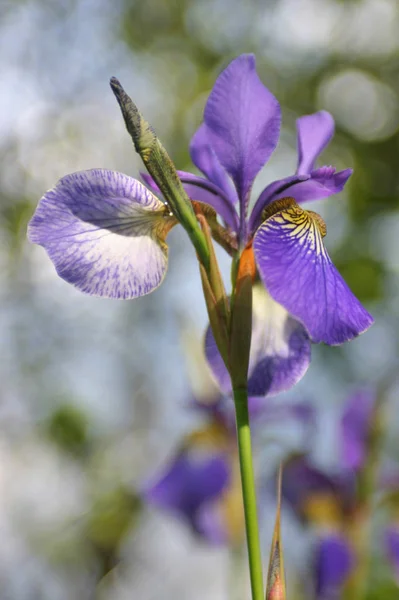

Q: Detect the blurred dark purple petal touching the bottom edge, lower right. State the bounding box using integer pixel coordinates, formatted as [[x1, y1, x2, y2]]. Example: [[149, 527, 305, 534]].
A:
[[314, 533, 354, 600]]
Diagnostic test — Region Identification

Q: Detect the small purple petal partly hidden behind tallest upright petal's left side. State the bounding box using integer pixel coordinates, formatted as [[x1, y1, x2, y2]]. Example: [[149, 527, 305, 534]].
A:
[[190, 123, 238, 204]]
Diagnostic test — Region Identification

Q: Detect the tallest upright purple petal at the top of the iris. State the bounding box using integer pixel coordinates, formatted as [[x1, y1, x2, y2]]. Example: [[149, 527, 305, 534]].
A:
[[204, 54, 281, 227]]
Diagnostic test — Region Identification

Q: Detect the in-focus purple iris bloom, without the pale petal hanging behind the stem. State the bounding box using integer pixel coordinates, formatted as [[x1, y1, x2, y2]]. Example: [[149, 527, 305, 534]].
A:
[[28, 55, 372, 344]]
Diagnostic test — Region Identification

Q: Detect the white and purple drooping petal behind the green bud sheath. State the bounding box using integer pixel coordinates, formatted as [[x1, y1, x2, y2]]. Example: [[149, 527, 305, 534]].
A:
[[205, 286, 311, 396]]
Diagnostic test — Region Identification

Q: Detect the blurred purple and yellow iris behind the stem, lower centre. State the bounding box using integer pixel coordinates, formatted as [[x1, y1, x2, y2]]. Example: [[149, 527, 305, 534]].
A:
[[142, 396, 313, 545]]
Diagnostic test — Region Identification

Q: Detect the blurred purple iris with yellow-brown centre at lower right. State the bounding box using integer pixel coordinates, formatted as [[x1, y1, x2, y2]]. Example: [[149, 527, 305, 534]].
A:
[[282, 390, 399, 600]]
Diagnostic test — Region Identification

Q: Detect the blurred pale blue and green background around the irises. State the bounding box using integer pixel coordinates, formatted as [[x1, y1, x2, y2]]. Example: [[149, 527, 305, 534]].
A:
[[0, 0, 399, 600]]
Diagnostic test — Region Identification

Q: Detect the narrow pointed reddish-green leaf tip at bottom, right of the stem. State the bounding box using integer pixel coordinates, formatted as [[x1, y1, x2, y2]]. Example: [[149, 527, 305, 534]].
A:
[[266, 464, 287, 600]]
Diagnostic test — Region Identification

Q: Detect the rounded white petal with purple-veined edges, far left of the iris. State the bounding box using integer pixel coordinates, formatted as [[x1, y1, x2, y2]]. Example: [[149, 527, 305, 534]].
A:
[[28, 169, 175, 299]]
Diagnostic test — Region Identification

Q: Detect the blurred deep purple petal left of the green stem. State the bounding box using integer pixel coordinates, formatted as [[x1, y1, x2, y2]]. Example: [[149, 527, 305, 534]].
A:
[[142, 447, 230, 531]]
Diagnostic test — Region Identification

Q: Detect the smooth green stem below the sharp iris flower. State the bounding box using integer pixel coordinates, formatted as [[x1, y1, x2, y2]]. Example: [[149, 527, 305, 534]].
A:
[[234, 388, 264, 600]]
